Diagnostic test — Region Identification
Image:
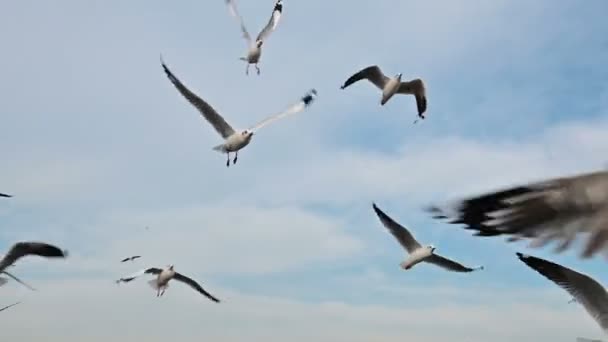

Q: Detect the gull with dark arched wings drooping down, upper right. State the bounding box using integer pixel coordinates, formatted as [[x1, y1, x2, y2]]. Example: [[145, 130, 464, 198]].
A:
[[340, 65, 427, 123]]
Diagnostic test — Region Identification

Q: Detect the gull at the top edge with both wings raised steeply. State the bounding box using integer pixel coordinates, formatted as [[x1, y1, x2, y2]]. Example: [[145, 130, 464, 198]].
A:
[[226, 0, 283, 75]]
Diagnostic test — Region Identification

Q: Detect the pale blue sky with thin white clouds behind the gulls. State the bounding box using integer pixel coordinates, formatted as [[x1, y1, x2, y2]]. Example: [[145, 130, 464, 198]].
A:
[[0, 0, 608, 342]]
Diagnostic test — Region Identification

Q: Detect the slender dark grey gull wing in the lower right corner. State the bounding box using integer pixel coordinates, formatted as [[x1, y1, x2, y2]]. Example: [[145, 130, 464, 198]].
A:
[[516, 252, 608, 333]]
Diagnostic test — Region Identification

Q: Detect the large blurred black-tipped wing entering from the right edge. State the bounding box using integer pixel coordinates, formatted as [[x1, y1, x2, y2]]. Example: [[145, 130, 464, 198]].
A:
[[425, 171, 608, 258]]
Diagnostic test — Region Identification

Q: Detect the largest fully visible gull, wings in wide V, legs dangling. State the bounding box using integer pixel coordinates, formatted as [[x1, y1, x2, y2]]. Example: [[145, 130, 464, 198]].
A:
[[161, 56, 317, 166]]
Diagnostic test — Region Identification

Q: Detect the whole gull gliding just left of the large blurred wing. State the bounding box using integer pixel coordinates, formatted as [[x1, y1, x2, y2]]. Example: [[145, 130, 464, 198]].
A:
[[373, 203, 483, 272]]
